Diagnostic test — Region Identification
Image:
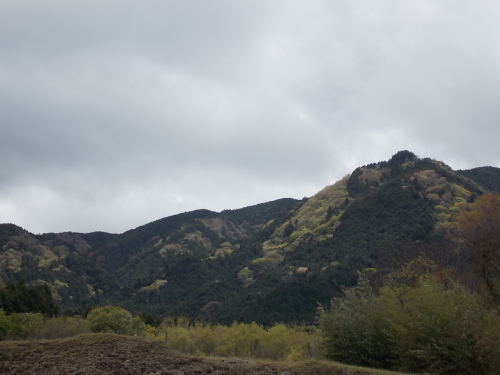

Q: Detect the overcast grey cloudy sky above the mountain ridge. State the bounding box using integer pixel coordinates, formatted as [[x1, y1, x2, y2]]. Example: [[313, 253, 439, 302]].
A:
[[0, 0, 500, 233]]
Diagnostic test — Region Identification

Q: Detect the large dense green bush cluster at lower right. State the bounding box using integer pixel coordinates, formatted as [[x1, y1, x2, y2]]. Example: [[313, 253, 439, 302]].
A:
[[319, 274, 500, 374]]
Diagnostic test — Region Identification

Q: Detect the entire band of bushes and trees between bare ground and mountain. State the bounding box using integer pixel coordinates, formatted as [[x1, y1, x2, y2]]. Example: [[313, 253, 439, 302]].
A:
[[0, 193, 500, 375]]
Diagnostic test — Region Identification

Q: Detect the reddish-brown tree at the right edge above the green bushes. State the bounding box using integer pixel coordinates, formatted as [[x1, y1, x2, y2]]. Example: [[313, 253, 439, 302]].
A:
[[453, 192, 500, 303]]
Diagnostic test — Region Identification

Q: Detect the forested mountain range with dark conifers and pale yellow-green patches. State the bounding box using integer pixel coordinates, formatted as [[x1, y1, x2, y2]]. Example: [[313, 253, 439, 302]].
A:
[[0, 151, 500, 324]]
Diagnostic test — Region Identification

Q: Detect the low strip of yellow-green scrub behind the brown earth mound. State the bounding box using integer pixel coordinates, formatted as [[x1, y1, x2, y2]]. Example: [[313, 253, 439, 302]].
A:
[[0, 306, 321, 360]]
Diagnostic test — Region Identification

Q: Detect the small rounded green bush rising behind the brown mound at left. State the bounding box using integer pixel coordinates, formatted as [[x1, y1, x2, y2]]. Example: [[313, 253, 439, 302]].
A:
[[87, 306, 146, 335]]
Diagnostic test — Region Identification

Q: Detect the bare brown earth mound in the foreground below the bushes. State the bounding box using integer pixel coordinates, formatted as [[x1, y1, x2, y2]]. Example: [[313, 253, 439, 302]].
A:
[[0, 334, 373, 375]]
